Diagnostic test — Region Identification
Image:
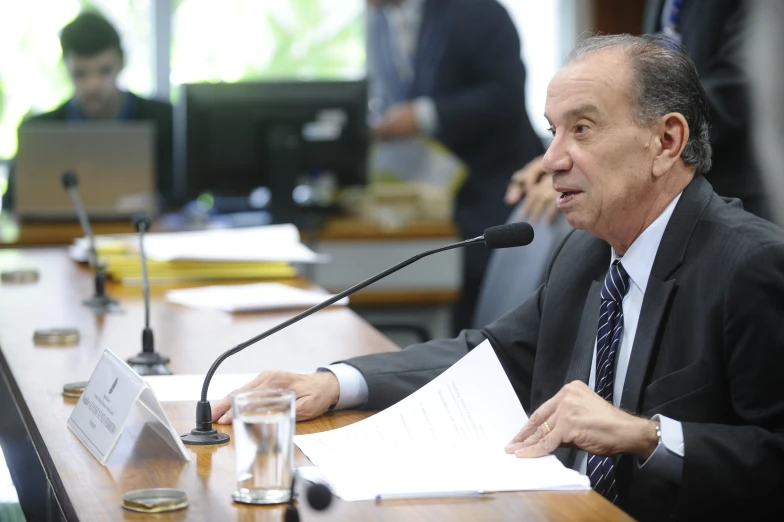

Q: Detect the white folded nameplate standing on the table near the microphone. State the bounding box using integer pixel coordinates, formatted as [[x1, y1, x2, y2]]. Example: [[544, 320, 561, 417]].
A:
[[68, 350, 191, 466]]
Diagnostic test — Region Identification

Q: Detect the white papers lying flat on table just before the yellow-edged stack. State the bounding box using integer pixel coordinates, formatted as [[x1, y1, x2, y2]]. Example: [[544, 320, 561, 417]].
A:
[[166, 283, 348, 312]]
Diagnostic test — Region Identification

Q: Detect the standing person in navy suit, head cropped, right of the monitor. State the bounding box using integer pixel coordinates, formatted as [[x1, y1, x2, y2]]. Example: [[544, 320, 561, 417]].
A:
[[367, 0, 542, 333]]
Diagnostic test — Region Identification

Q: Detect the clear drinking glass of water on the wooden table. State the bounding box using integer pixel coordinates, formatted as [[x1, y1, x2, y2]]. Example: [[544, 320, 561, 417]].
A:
[[231, 390, 296, 504]]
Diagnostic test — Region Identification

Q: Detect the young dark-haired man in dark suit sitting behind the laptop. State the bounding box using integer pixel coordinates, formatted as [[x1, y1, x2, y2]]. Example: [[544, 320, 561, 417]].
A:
[[3, 11, 173, 208]]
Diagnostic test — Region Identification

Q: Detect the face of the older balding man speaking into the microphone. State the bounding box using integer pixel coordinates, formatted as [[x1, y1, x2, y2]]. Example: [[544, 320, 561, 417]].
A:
[[542, 49, 654, 239]]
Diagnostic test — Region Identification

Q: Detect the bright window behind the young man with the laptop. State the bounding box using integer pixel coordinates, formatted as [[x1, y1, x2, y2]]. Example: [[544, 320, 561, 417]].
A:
[[0, 0, 153, 160]]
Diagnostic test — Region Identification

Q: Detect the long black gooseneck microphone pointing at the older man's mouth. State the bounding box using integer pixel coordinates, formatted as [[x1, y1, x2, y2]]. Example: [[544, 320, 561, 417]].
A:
[[180, 221, 534, 445]]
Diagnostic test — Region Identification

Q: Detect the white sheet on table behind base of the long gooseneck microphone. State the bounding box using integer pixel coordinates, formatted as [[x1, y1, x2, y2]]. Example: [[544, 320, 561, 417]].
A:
[[144, 372, 258, 402]]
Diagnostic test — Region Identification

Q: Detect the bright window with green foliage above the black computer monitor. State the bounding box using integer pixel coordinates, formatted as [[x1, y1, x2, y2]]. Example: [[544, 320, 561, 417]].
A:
[[170, 0, 365, 96]]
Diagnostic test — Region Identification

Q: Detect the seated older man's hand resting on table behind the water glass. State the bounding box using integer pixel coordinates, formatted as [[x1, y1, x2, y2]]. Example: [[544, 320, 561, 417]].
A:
[[212, 370, 340, 424]]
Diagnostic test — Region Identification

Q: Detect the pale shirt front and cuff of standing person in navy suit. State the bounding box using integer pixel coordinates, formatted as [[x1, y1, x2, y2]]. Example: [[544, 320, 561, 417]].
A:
[[376, 0, 438, 135]]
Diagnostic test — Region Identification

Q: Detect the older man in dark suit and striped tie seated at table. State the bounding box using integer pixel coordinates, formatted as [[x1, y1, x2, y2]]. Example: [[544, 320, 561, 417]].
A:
[[214, 35, 784, 520]]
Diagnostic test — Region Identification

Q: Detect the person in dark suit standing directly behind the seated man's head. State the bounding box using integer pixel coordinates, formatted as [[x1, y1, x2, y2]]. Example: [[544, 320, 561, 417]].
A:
[[504, 0, 771, 221]]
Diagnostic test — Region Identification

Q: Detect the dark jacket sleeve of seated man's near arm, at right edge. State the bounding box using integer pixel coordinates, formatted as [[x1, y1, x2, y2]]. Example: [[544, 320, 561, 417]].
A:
[[680, 243, 784, 518]]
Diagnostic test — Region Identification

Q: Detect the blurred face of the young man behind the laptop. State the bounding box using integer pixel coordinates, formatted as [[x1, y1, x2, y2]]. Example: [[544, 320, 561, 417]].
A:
[[65, 49, 123, 117]]
